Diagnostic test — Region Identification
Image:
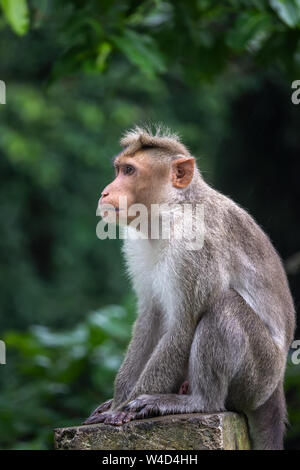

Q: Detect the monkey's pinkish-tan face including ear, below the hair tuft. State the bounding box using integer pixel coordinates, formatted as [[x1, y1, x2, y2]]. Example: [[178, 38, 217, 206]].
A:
[[99, 150, 194, 223]]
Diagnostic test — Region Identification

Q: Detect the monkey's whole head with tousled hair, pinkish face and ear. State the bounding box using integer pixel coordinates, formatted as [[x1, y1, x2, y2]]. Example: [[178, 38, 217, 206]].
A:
[[99, 128, 195, 222]]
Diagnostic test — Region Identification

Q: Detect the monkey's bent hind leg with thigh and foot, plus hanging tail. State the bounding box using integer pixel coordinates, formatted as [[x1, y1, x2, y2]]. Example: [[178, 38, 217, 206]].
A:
[[119, 291, 285, 449]]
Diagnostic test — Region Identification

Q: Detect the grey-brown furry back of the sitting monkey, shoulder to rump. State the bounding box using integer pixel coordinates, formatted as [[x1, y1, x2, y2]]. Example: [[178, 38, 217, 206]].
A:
[[204, 188, 295, 349]]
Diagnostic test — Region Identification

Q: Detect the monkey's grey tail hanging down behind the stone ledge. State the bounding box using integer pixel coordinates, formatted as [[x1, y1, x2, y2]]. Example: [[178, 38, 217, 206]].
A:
[[246, 382, 288, 450]]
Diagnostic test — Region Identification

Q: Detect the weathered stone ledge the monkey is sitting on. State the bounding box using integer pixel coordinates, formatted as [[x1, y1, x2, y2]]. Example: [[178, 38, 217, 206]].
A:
[[54, 412, 250, 450]]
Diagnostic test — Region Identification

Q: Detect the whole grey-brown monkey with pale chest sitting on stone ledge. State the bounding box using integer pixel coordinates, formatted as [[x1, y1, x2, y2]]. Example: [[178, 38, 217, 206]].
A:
[[84, 126, 295, 449]]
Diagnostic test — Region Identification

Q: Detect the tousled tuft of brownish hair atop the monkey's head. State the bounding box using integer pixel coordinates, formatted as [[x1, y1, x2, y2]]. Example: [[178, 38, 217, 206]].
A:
[[120, 124, 190, 156]]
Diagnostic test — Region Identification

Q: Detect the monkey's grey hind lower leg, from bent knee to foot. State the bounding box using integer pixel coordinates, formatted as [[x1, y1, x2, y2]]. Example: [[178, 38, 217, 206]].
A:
[[119, 296, 239, 419]]
